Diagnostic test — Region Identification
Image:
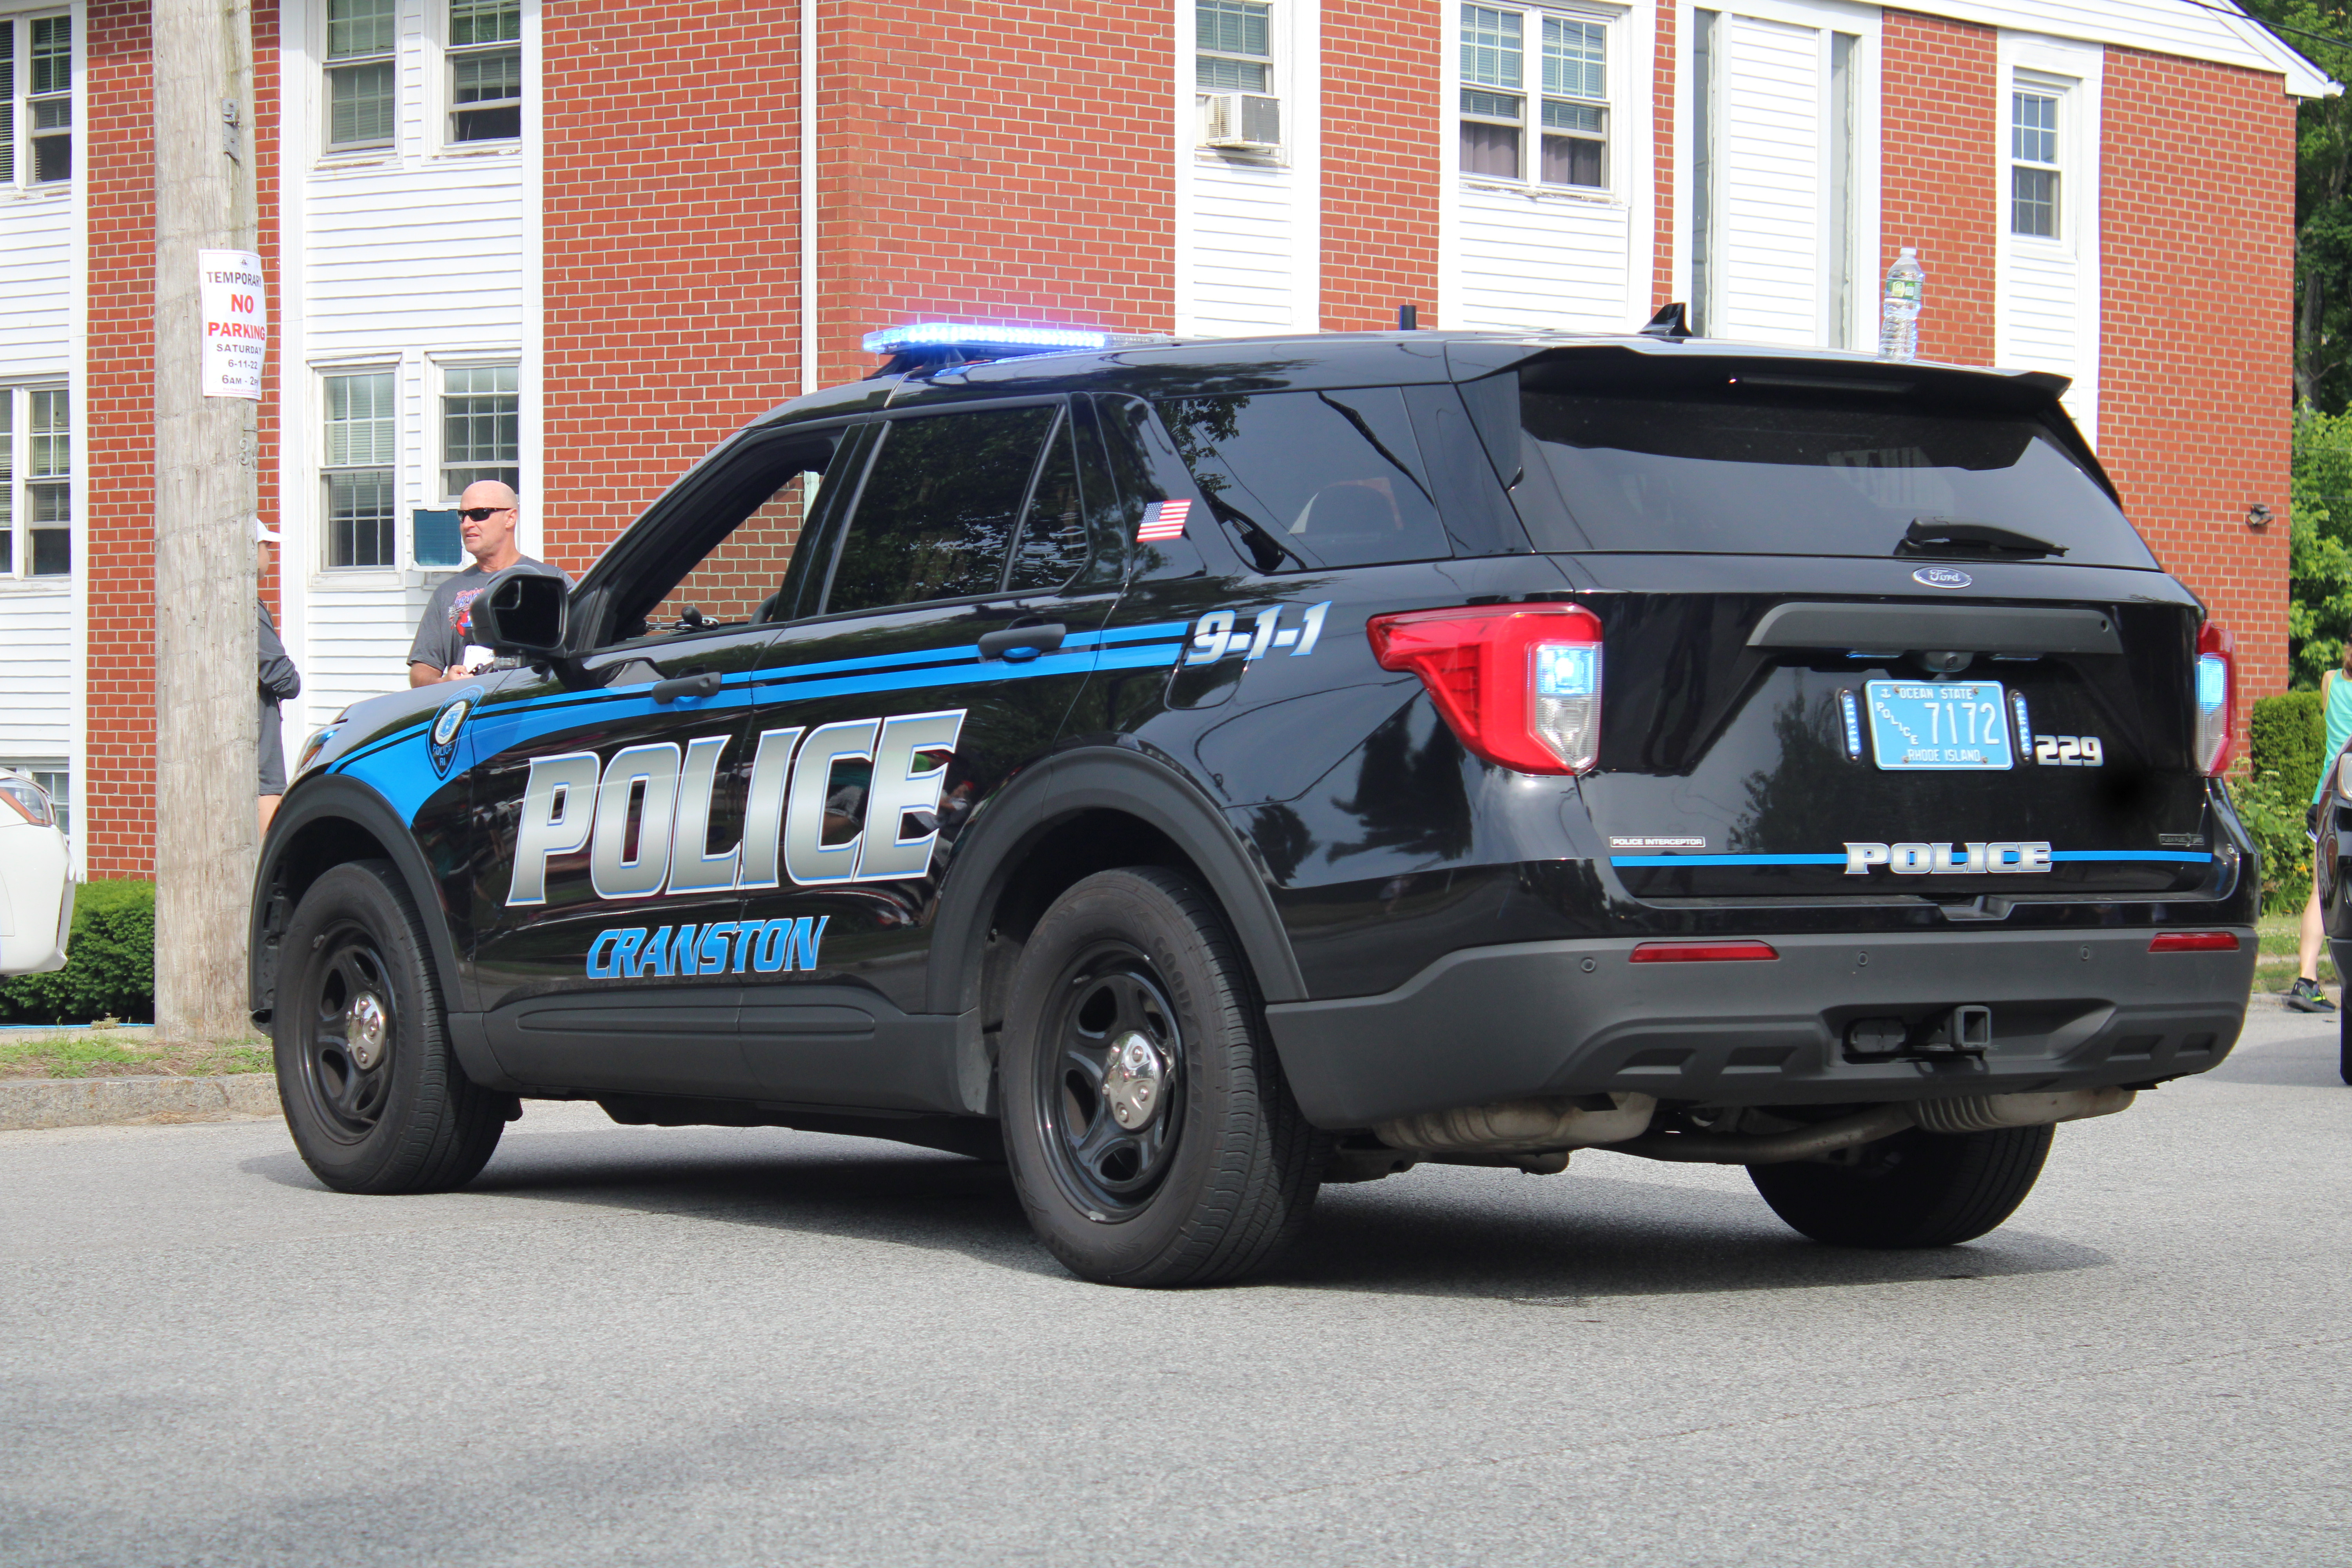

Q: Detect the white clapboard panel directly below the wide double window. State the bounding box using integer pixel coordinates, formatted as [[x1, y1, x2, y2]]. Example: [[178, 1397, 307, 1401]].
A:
[[1446, 188, 1630, 332]]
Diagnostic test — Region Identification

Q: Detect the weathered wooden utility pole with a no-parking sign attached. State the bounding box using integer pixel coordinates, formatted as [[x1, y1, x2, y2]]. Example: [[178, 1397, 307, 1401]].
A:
[[153, 0, 259, 1039]]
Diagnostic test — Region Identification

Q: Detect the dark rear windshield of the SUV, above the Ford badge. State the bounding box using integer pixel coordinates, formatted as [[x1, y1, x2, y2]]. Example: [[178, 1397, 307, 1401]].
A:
[[1519, 379, 2154, 566]]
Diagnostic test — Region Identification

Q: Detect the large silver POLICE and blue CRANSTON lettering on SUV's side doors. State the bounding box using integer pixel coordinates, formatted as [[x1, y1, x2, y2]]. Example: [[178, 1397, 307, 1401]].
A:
[[506, 708, 964, 912]]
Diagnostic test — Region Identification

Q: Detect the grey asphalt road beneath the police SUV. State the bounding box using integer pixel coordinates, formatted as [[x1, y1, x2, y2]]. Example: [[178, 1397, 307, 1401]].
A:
[[0, 1011, 2352, 1568]]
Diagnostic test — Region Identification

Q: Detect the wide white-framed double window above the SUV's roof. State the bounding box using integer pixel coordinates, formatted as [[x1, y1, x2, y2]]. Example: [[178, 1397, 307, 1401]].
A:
[[1461, 5, 1609, 191]]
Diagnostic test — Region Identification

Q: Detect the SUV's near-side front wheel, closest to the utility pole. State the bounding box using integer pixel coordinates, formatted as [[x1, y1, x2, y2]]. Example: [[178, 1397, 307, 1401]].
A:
[[270, 860, 515, 1194]]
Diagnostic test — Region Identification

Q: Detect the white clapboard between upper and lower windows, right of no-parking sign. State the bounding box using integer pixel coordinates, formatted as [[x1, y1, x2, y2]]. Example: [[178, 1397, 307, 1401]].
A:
[[303, 158, 522, 362]]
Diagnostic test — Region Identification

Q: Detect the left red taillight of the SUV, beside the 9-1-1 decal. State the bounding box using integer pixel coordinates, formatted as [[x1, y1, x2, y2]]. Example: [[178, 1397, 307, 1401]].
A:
[[1364, 604, 1602, 773]]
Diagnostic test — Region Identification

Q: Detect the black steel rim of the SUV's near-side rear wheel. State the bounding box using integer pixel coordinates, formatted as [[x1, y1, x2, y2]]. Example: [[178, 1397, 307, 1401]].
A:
[[1033, 943, 1190, 1222]]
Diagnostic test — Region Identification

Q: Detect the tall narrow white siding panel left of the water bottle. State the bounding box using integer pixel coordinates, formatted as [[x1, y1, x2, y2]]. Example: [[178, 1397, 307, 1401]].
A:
[[1710, 16, 1820, 346]]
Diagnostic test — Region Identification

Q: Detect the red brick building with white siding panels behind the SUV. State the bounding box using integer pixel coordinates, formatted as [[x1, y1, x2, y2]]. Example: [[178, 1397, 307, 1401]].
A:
[[0, 0, 2333, 875]]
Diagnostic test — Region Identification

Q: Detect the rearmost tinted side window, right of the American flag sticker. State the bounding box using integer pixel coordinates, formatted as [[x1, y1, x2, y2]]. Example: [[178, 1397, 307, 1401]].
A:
[[1160, 386, 1451, 571]]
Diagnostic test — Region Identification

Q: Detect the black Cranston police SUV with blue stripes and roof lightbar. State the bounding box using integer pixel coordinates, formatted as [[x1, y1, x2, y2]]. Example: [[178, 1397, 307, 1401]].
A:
[[252, 322, 2258, 1286]]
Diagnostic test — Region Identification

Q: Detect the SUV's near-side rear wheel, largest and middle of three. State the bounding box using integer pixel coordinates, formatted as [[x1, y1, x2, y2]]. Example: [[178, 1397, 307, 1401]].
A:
[[997, 865, 1329, 1286]]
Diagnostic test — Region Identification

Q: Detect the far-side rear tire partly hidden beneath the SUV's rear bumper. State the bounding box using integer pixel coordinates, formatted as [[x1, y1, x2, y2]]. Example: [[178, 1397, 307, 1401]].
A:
[[1748, 1124, 2051, 1248]]
